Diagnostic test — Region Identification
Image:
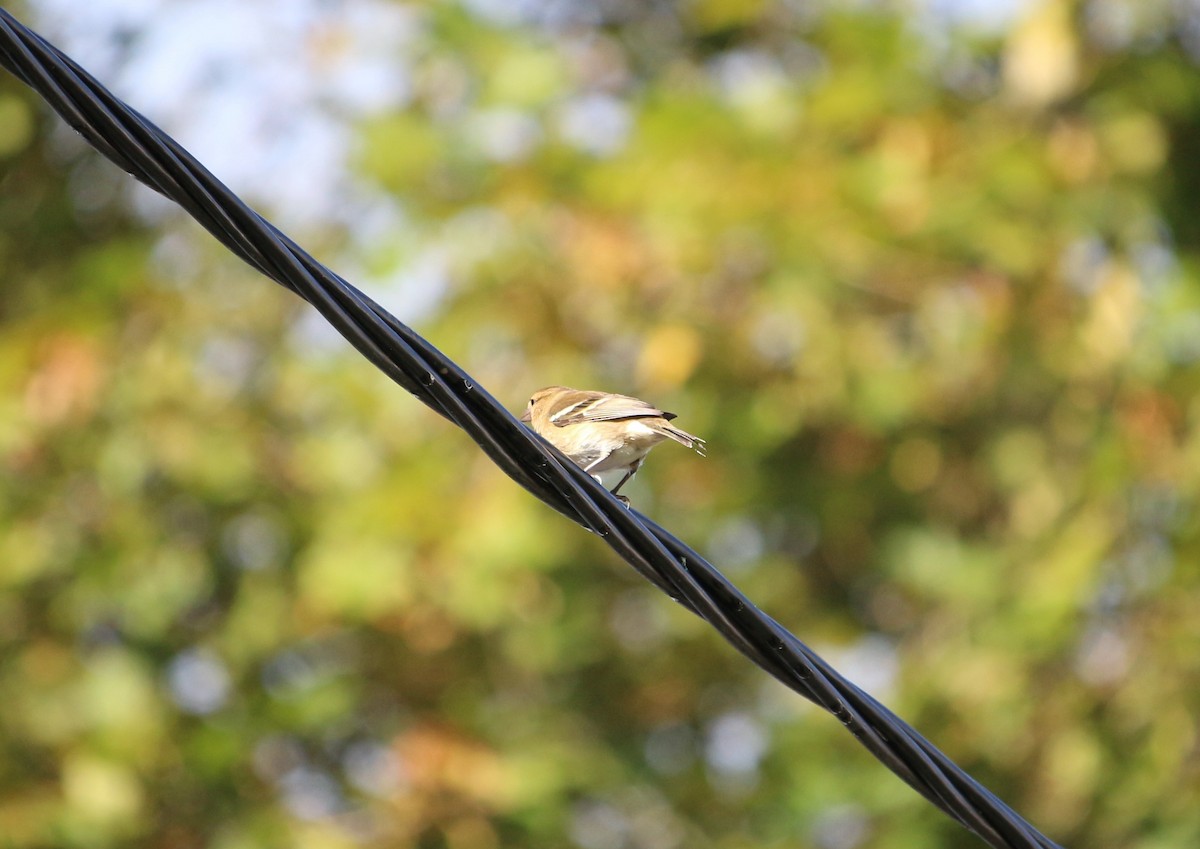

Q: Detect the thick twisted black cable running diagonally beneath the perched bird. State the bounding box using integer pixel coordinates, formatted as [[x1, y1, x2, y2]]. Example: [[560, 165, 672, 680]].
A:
[[0, 8, 1057, 849]]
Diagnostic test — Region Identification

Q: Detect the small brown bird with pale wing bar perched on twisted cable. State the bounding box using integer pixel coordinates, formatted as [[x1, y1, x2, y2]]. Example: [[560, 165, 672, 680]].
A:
[[521, 386, 704, 504]]
